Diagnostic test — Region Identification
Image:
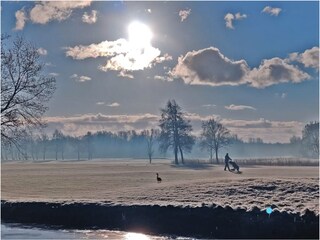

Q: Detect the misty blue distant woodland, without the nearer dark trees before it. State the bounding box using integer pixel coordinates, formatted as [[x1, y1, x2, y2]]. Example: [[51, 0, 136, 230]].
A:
[[1, 115, 317, 163]]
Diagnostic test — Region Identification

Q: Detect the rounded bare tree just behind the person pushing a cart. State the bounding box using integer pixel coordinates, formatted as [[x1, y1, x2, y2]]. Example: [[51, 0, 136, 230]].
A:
[[200, 119, 230, 163]]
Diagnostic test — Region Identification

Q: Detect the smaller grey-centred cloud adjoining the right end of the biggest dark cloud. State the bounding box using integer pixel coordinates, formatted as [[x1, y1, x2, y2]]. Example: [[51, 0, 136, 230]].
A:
[[248, 57, 311, 88]]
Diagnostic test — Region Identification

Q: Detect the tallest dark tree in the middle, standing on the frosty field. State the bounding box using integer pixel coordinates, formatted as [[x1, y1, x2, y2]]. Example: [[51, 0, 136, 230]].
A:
[[159, 100, 195, 164]]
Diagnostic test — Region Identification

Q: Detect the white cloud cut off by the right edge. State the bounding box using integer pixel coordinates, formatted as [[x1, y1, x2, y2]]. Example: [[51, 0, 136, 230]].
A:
[[288, 47, 319, 71]]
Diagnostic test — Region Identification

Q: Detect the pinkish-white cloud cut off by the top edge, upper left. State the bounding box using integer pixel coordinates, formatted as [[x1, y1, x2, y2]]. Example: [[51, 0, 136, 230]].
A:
[[30, 0, 91, 24]]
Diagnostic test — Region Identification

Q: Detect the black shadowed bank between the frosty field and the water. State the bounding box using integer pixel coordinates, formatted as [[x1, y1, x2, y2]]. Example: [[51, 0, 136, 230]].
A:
[[1, 201, 319, 239]]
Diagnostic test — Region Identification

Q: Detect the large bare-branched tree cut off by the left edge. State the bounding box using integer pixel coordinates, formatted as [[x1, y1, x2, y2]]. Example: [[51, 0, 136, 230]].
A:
[[1, 36, 56, 144]]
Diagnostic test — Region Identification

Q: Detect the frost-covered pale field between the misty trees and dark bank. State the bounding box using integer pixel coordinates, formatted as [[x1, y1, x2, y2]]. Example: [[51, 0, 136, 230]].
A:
[[1, 160, 319, 215]]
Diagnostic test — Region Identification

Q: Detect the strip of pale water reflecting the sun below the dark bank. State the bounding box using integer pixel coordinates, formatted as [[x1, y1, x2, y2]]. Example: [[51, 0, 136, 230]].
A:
[[1, 224, 194, 240]]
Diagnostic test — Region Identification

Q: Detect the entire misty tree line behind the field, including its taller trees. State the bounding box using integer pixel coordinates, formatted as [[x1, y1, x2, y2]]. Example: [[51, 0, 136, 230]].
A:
[[1, 101, 319, 164]]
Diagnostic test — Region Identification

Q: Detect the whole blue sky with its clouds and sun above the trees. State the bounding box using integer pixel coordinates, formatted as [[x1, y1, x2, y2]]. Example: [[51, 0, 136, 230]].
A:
[[1, 1, 319, 143]]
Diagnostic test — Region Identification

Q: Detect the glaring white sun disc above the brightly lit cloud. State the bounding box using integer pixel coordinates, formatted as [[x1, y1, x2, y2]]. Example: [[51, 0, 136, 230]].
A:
[[128, 22, 152, 48]]
